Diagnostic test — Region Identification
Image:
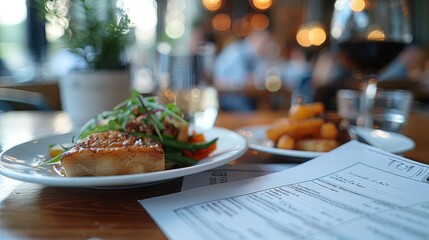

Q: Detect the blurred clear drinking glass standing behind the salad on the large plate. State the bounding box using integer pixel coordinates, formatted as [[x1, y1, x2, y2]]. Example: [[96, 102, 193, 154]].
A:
[[157, 42, 219, 131]]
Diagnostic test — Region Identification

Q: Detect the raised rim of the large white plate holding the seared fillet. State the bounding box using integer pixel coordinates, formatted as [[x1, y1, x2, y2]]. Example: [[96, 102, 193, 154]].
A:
[[0, 127, 249, 187]]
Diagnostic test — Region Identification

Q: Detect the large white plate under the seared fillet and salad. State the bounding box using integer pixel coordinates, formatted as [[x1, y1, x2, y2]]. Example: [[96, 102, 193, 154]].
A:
[[0, 128, 247, 188]]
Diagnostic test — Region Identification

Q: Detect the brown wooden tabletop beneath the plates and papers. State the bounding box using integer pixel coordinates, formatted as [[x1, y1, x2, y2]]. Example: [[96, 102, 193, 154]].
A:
[[0, 112, 429, 239]]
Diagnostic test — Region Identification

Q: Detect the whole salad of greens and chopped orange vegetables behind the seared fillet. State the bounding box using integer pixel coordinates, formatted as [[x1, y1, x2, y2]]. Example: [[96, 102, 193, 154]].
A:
[[45, 90, 218, 166]]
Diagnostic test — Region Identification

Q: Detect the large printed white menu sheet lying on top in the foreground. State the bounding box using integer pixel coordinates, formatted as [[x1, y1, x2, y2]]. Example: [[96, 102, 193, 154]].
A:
[[139, 141, 429, 239]]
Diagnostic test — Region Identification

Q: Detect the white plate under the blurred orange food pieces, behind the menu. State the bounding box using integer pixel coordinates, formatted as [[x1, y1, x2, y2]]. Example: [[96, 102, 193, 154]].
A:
[[238, 125, 415, 161]]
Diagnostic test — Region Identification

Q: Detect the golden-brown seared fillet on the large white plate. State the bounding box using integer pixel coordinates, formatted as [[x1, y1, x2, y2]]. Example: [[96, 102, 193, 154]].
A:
[[61, 131, 165, 177]]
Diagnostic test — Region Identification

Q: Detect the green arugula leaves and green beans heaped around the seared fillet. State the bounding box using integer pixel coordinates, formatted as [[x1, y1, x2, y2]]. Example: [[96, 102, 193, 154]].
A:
[[43, 90, 218, 165]]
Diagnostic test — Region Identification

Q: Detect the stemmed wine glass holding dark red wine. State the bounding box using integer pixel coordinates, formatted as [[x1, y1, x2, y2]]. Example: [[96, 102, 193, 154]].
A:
[[331, 0, 412, 127]]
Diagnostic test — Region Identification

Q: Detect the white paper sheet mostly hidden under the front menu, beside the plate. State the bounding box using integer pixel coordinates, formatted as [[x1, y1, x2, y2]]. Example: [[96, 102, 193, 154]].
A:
[[182, 163, 298, 191]]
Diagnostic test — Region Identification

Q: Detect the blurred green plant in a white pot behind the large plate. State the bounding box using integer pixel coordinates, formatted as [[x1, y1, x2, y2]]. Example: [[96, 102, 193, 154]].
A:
[[42, 0, 134, 126]]
